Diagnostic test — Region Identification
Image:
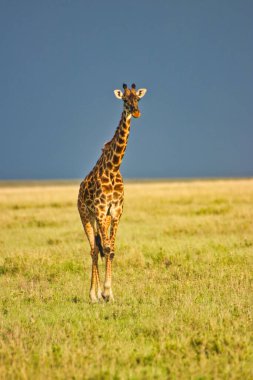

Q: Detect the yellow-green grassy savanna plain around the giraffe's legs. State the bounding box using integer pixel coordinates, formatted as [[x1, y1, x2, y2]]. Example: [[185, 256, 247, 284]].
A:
[[0, 180, 253, 380]]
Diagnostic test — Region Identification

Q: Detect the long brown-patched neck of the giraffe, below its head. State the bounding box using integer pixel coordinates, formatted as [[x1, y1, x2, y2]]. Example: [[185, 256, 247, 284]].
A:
[[102, 110, 131, 172]]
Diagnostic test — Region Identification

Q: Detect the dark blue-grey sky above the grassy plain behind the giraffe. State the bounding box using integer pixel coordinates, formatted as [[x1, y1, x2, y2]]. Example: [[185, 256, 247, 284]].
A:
[[0, 0, 253, 179]]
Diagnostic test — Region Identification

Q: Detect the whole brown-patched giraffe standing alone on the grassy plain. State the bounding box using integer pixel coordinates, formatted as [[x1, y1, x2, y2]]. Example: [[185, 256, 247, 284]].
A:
[[77, 83, 147, 302]]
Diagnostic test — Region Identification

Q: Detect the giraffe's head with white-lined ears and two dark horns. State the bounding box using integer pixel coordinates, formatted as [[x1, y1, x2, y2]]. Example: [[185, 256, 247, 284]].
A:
[[114, 83, 147, 118]]
